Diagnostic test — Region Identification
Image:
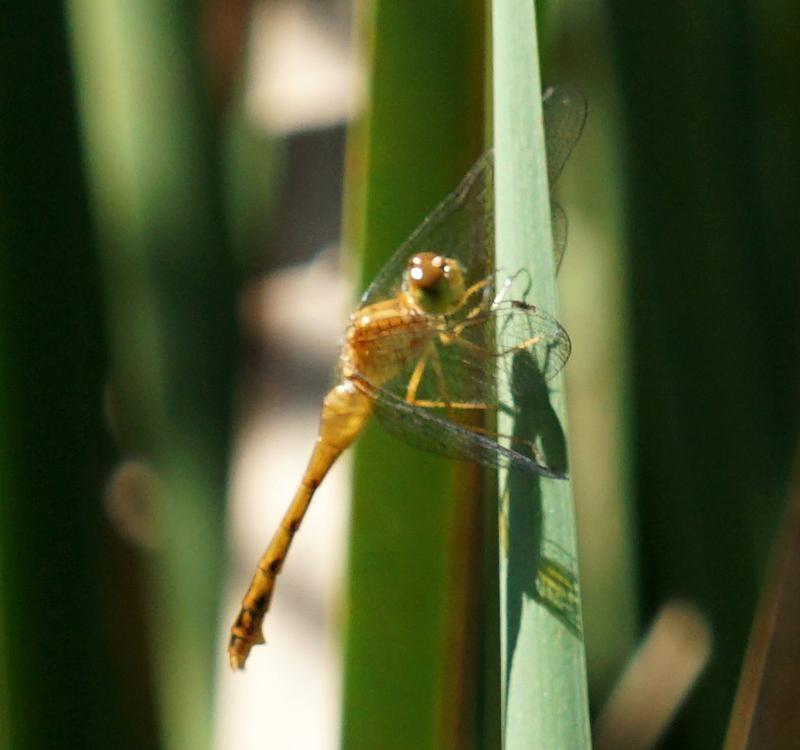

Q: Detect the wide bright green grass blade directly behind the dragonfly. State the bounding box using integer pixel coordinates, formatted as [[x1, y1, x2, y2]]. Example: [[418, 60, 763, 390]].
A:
[[343, 0, 484, 750]]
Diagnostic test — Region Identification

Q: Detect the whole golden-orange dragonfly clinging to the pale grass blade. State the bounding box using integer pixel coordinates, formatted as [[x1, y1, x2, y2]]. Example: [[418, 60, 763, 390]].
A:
[[228, 87, 586, 670]]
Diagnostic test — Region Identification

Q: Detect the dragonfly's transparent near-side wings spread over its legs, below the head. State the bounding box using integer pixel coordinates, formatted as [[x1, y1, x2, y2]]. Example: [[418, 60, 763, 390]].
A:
[[364, 301, 570, 476]]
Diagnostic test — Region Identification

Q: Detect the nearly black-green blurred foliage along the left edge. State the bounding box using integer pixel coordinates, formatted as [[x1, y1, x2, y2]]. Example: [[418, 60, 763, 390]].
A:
[[0, 2, 156, 750]]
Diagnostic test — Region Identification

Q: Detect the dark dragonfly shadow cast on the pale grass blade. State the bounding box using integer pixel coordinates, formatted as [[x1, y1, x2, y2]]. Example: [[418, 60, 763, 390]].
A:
[[503, 351, 581, 720]]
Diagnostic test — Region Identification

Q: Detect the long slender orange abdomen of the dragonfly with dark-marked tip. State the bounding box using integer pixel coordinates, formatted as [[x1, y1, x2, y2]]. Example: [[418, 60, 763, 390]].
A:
[[228, 381, 373, 669]]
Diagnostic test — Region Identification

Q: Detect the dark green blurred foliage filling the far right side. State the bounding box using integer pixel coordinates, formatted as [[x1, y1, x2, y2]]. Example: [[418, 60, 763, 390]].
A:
[[608, 0, 800, 748]]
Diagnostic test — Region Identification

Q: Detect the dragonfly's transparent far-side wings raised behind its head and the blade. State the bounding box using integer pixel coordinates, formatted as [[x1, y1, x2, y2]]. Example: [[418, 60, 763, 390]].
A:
[[361, 86, 586, 307]]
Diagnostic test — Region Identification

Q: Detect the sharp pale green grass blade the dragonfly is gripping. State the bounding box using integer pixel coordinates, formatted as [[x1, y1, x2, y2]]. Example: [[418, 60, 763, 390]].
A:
[[492, 0, 590, 750]]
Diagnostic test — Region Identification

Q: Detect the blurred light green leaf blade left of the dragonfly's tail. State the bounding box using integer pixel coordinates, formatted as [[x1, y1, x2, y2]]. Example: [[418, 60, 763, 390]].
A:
[[69, 0, 236, 750]]
